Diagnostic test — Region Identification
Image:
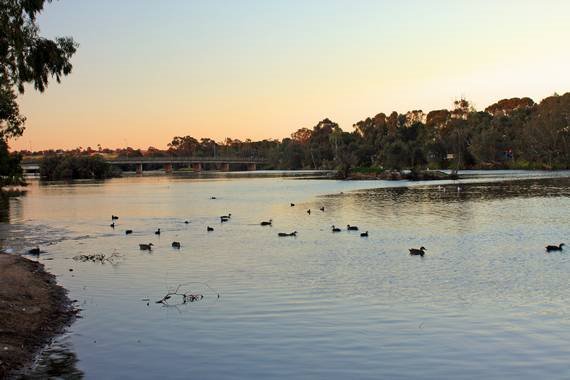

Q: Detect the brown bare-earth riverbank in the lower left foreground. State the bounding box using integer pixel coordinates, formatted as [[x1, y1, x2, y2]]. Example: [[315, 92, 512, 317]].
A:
[[0, 253, 76, 379]]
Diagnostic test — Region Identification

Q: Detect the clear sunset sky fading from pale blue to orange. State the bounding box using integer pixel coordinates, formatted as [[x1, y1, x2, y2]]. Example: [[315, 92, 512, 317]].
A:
[[11, 0, 570, 150]]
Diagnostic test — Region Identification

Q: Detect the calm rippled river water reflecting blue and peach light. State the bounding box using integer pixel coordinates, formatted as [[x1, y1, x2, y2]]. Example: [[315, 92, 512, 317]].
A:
[[0, 172, 570, 379]]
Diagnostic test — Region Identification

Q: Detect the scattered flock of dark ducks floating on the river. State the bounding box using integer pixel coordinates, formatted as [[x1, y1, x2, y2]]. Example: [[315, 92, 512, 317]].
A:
[[28, 202, 565, 257]]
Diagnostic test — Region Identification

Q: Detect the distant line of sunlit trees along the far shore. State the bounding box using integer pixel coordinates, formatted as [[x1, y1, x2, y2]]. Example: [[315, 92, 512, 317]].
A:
[[17, 93, 570, 174]]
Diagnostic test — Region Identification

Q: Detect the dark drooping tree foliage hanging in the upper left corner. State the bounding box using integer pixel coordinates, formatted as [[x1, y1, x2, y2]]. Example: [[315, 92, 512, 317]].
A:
[[0, 0, 77, 140]]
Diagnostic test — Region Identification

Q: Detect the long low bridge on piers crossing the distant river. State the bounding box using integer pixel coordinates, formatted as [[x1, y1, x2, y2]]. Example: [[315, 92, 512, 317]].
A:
[[22, 156, 267, 174]]
